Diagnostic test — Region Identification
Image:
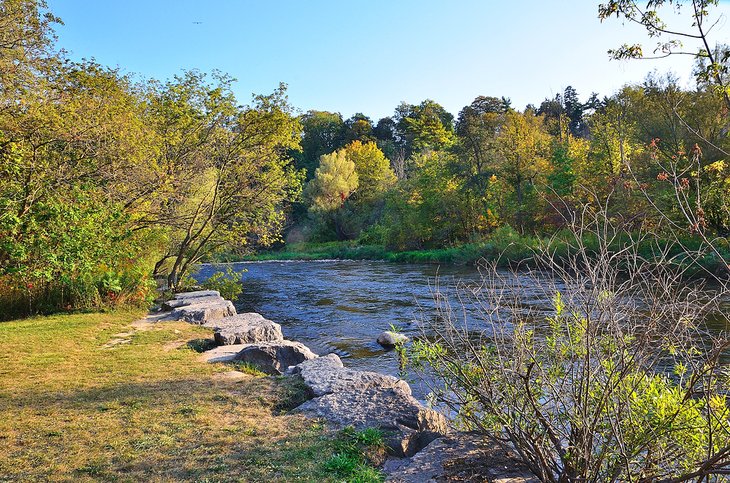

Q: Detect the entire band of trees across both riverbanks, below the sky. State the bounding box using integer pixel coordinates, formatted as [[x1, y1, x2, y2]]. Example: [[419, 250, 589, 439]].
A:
[[0, 0, 730, 317]]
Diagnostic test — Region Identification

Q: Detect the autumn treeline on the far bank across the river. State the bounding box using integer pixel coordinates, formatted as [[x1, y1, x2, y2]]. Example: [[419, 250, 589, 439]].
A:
[[287, 81, 730, 250]]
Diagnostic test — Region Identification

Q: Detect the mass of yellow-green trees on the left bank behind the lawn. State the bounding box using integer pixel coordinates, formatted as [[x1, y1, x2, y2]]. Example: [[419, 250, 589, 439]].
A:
[[0, 0, 301, 318]]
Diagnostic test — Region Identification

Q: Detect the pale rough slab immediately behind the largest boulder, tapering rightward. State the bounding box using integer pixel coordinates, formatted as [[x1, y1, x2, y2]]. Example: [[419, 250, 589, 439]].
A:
[[293, 354, 411, 397]]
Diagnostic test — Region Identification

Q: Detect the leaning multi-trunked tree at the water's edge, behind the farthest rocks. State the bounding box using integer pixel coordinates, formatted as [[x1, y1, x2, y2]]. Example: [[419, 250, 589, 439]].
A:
[[151, 78, 300, 288]]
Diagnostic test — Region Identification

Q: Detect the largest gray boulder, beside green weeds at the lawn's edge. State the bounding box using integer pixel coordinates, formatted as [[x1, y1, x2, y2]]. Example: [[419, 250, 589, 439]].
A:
[[295, 387, 448, 456]]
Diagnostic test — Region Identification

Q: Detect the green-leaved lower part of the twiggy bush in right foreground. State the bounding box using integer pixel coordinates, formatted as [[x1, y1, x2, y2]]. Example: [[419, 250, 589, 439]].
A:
[[410, 284, 730, 481]]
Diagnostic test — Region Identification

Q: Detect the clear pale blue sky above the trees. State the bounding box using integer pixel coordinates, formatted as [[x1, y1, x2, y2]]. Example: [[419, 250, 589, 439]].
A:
[[48, 0, 730, 120]]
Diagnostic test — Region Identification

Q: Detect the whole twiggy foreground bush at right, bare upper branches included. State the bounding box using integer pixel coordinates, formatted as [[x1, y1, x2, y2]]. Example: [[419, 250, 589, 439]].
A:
[[410, 210, 730, 482]]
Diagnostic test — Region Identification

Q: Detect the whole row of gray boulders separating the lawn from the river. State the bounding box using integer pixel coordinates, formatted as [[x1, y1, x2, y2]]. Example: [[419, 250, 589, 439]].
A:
[[156, 290, 534, 483]]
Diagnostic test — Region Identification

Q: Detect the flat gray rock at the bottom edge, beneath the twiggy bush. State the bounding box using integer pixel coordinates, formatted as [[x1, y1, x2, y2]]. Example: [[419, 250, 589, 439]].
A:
[[385, 433, 538, 483]]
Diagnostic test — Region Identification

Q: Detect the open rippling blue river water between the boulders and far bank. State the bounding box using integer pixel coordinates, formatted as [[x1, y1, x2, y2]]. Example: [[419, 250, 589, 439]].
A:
[[196, 260, 725, 395]]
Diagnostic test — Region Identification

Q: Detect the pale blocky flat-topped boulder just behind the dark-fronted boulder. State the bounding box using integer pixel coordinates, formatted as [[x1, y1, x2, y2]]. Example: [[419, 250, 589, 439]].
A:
[[204, 312, 284, 345]]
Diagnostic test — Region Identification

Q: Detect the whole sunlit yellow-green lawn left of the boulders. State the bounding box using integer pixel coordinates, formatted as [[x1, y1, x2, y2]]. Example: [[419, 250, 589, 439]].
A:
[[0, 312, 382, 482]]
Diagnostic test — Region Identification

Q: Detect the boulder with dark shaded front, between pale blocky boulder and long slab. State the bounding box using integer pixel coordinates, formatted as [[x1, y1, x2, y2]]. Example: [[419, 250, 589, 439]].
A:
[[235, 340, 317, 375]]
